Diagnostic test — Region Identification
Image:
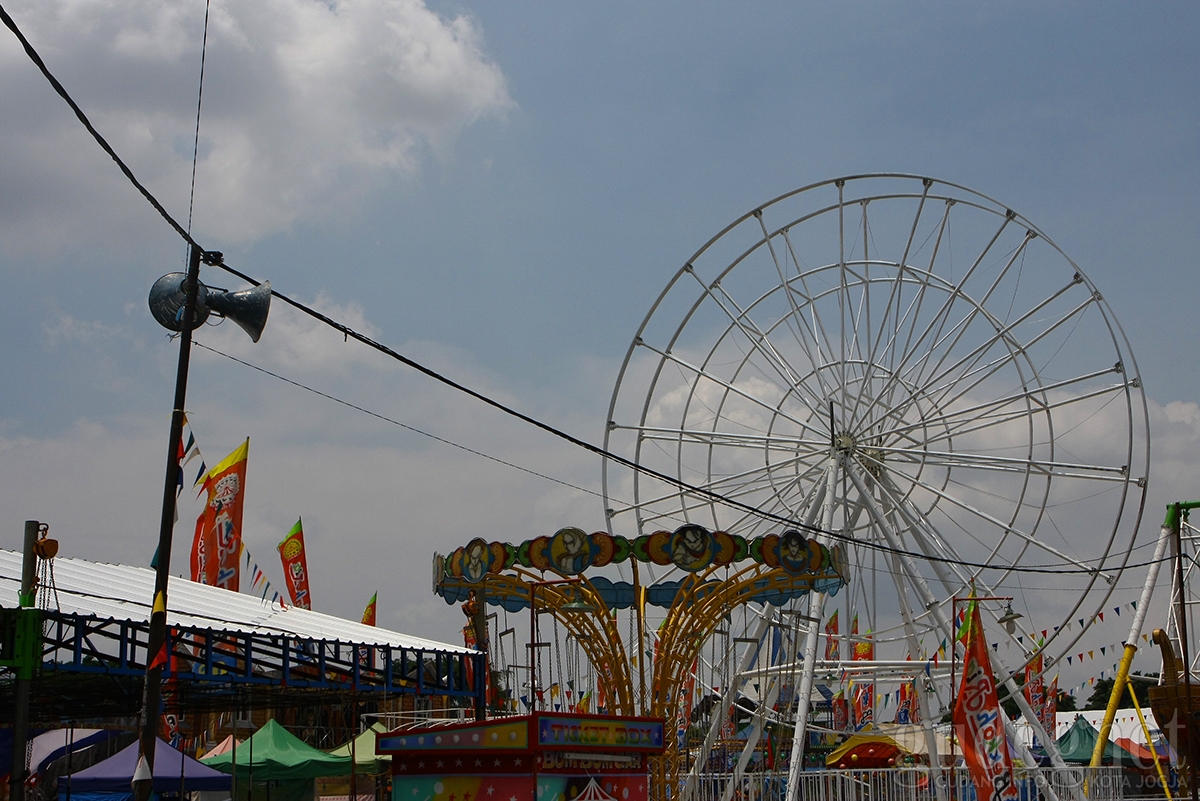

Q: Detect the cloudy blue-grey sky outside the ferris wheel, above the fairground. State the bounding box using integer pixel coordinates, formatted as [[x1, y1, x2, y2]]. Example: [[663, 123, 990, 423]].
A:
[[0, 0, 1200, 700]]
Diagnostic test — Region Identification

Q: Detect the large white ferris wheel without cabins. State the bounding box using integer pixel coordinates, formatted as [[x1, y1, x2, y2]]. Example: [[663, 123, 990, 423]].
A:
[[602, 175, 1150, 724]]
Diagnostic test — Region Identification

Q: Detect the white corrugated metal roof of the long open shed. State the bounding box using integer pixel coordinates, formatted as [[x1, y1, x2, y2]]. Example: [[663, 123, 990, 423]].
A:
[[0, 549, 475, 654]]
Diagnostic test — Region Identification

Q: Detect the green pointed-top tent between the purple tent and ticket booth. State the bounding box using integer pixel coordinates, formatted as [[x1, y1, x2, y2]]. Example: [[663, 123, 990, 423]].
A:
[[202, 721, 350, 783]]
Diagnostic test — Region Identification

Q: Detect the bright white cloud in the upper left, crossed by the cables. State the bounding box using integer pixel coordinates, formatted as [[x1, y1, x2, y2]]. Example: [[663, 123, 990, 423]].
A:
[[0, 0, 512, 252]]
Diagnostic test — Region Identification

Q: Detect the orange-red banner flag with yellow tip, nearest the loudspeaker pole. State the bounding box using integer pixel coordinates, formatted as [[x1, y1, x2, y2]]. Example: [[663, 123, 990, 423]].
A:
[[192, 439, 250, 592]]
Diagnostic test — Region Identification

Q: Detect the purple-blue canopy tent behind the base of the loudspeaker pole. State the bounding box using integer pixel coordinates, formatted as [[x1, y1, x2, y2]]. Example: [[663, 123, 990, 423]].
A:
[[59, 740, 230, 801]]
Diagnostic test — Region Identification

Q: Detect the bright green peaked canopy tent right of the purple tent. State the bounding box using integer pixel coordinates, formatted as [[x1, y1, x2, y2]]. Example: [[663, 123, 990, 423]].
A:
[[200, 721, 350, 801]]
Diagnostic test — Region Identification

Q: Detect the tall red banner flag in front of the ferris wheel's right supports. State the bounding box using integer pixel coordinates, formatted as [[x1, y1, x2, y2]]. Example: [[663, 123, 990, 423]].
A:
[[954, 601, 1020, 801]]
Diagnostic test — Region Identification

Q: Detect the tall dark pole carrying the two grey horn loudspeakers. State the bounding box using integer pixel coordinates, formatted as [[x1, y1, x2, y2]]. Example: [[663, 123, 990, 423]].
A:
[[133, 245, 204, 801]]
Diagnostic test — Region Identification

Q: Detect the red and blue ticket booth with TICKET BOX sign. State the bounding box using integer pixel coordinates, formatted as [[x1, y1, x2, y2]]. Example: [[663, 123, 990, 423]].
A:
[[376, 712, 664, 801]]
